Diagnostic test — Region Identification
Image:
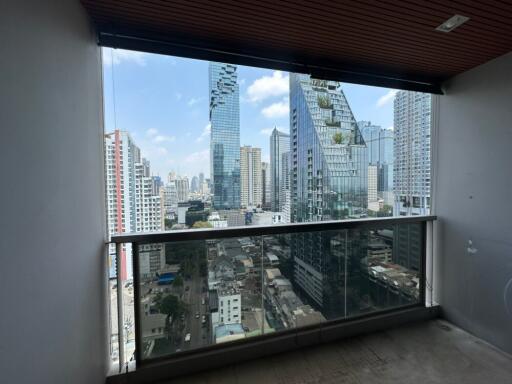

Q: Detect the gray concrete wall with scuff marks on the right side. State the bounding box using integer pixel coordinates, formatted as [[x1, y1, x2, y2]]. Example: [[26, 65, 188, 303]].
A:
[[434, 53, 512, 353]]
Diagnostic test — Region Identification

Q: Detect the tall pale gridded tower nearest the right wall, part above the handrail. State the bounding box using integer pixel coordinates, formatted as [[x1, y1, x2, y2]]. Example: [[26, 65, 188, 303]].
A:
[[393, 91, 431, 215]]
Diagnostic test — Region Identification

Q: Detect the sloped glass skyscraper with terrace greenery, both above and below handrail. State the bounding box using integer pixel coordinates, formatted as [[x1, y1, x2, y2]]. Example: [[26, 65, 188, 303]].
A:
[[290, 74, 368, 318]]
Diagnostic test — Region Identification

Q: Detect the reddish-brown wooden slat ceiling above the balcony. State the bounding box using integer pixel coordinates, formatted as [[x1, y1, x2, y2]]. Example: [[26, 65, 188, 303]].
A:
[[82, 0, 512, 91]]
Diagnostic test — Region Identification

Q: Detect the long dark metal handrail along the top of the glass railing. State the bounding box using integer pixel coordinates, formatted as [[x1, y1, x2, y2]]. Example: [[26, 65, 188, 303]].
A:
[[111, 215, 437, 244]]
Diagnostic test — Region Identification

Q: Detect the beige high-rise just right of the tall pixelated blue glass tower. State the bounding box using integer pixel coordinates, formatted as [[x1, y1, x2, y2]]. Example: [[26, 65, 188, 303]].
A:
[[240, 146, 262, 208]]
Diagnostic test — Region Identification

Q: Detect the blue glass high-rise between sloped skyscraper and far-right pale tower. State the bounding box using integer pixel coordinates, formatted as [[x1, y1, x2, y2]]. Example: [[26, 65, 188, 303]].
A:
[[358, 121, 394, 206]]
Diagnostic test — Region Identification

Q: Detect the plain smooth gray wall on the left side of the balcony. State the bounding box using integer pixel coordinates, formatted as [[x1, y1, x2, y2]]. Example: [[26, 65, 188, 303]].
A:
[[0, 0, 107, 384]]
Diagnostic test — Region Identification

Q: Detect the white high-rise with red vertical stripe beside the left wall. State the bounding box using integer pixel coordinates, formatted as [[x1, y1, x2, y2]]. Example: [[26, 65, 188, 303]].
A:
[[105, 130, 162, 280]]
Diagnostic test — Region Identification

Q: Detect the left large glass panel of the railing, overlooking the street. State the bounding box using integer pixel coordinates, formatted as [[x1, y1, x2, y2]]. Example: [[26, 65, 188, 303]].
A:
[[139, 237, 262, 359]]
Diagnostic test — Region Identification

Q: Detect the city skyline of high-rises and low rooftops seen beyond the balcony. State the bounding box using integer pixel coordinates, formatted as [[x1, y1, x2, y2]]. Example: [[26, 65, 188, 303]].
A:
[[105, 55, 430, 357]]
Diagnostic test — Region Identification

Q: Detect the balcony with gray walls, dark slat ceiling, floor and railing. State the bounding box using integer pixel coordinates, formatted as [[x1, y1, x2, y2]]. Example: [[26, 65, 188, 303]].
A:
[[4, 0, 512, 384]]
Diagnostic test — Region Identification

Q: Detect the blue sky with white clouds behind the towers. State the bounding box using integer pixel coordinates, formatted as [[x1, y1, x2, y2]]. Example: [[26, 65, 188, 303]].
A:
[[103, 48, 395, 178]]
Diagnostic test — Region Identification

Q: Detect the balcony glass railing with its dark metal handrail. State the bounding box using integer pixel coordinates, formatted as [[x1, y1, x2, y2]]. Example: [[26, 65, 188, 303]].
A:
[[112, 216, 434, 364]]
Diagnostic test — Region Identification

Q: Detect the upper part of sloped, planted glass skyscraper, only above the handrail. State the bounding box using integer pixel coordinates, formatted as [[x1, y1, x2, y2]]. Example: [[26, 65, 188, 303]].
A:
[[290, 74, 368, 222]]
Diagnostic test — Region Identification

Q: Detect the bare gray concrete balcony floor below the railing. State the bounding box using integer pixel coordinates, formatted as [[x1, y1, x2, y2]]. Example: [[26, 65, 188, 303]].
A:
[[169, 320, 512, 384]]
